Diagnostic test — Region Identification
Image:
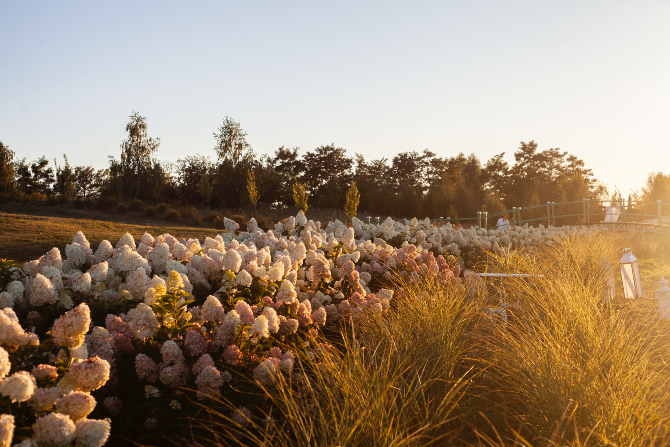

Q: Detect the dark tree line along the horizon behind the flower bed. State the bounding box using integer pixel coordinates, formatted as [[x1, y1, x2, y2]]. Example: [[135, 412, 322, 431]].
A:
[[0, 112, 670, 218]]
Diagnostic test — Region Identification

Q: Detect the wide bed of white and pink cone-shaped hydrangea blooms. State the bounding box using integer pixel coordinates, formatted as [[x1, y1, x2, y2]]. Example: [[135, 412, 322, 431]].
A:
[[0, 212, 592, 447]]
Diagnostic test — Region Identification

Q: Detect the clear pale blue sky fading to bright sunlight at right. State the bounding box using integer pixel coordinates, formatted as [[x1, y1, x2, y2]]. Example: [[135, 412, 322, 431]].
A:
[[0, 0, 670, 194]]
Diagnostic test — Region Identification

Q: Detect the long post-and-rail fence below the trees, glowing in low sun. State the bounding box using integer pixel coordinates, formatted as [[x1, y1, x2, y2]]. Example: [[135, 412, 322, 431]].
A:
[[368, 198, 670, 228]]
